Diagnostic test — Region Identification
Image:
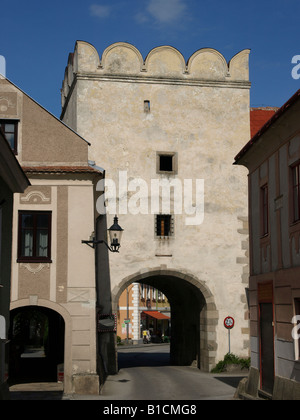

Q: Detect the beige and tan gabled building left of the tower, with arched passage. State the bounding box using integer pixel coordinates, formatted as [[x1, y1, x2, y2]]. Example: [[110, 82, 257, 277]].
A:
[[0, 79, 102, 393]]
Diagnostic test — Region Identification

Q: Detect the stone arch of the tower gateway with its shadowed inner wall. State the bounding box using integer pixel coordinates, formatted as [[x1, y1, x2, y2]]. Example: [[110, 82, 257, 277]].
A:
[[112, 268, 219, 372]]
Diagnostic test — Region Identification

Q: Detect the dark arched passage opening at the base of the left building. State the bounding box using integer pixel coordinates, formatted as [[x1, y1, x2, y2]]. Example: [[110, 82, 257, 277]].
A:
[[9, 306, 65, 383]]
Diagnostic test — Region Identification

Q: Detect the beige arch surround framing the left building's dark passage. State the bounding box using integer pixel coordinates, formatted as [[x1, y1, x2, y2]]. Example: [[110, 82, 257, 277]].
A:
[[10, 299, 72, 393]]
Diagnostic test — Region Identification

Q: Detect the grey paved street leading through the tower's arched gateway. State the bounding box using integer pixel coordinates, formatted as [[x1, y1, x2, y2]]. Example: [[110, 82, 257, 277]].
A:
[[11, 345, 246, 401]]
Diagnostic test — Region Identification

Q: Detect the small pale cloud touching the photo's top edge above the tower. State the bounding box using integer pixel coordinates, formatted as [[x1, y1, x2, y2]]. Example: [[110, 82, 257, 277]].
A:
[[147, 0, 187, 24]]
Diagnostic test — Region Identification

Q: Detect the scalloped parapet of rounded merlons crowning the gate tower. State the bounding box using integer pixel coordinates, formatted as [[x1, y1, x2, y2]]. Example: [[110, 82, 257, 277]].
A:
[[62, 41, 250, 106]]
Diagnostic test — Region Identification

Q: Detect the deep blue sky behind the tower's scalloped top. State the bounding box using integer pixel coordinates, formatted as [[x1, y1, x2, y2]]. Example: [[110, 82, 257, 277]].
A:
[[0, 0, 300, 117]]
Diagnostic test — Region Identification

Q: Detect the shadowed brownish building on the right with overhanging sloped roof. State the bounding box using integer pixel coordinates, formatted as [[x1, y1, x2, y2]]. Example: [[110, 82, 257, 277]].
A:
[[235, 91, 300, 399]]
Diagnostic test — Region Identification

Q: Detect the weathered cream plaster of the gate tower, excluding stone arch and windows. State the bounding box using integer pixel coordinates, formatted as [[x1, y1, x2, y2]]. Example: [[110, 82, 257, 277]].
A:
[[61, 41, 250, 359]]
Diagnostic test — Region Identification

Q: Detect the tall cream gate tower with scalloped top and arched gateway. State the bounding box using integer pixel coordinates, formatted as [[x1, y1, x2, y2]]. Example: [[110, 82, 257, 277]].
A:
[[61, 41, 250, 370]]
